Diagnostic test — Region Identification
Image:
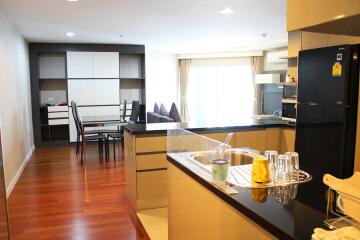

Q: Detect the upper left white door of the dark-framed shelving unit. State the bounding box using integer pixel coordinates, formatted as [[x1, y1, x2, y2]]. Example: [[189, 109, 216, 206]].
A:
[[67, 52, 94, 78]]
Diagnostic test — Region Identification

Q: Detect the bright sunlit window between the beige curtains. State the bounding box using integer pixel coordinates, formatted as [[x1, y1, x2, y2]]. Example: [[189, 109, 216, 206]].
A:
[[188, 59, 254, 125]]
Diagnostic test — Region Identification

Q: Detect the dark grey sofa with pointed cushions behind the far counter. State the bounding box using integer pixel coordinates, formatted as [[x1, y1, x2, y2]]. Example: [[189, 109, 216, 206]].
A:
[[147, 103, 181, 123]]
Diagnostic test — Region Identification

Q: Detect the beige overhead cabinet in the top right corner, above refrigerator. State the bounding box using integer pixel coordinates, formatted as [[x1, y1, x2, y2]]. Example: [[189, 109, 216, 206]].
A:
[[287, 0, 360, 31]]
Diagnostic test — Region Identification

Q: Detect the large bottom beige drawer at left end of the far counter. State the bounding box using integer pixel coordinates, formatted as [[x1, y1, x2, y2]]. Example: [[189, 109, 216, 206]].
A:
[[136, 170, 167, 200]]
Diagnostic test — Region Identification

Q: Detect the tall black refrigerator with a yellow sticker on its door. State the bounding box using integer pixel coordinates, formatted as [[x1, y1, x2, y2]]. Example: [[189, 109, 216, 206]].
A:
[[295, 45, 360, 179]]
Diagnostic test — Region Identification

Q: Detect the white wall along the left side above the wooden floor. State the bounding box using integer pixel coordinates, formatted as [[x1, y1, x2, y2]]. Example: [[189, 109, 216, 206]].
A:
[[0, 13, 34, 194]]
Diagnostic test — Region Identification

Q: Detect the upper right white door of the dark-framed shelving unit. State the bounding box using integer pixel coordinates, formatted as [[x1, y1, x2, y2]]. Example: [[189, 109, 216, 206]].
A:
[[94, 52, 119, 78]]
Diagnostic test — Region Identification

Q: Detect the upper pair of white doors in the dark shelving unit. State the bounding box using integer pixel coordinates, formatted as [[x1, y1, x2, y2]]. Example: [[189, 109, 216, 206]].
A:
[[67, 52, 119, 78]]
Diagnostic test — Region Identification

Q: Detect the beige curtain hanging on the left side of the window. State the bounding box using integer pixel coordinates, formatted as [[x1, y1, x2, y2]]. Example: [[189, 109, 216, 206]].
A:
[[179, 59, 191, 122]]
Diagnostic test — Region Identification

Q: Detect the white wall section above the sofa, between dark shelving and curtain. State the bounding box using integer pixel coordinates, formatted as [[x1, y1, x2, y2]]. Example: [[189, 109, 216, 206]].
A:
[[145, 49, 180, 112]]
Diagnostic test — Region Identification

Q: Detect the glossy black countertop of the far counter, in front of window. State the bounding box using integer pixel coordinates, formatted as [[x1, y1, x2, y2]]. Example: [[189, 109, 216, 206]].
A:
[[124, 119, 295, 135]]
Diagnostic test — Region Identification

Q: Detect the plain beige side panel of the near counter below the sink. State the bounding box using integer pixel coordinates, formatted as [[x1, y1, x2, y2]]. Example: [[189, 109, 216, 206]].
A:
[[168, 162, 277, 240]]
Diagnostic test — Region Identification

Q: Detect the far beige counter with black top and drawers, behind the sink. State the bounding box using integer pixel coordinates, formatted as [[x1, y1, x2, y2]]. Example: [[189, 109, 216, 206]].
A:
[[124, 119, 295, 212]]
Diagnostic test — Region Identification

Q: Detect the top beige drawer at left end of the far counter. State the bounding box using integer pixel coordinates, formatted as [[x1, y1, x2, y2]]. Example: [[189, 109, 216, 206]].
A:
[[135, 136, 167, 153]]
